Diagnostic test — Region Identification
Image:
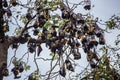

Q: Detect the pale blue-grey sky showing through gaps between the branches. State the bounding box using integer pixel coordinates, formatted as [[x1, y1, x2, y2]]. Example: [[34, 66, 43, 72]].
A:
[[4, 0, 120, 80]]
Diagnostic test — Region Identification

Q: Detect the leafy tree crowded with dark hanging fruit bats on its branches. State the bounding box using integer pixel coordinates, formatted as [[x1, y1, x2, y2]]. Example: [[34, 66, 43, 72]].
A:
[[0, 0, 120, 80]]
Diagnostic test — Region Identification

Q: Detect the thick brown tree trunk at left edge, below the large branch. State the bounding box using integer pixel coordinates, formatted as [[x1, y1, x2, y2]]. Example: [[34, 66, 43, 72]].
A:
[[0, 39, 9, 80]]
